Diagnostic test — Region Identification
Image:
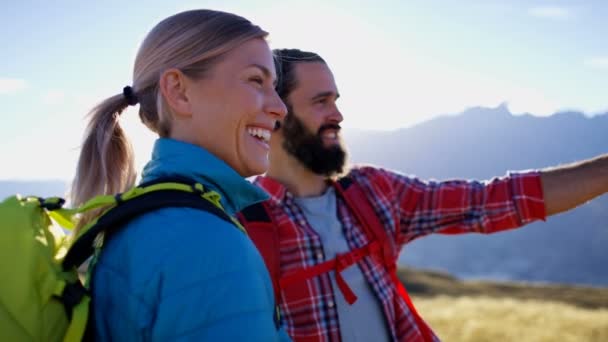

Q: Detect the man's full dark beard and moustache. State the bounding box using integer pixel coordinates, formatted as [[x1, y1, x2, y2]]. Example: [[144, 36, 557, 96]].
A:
[[281, 113, 346, 177]]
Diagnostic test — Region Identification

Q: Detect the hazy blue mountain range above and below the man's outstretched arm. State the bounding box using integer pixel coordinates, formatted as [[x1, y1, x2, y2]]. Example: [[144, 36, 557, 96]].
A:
[[345, 106, 608, 286]]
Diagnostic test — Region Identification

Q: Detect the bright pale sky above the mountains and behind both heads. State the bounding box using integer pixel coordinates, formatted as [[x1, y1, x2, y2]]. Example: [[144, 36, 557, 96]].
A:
[[0, 0, 608, 180]]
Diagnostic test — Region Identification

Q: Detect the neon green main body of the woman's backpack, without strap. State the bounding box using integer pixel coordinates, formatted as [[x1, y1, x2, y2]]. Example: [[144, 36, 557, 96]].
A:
[[0, 196, 84, 341]]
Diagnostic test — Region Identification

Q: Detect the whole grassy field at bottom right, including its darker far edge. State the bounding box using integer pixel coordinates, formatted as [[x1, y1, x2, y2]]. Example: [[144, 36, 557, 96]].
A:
[[399, 270, 608, 342]]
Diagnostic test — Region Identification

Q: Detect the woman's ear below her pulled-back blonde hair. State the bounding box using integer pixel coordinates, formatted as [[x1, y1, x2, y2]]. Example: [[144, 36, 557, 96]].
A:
[[158, 69, 192, 117]]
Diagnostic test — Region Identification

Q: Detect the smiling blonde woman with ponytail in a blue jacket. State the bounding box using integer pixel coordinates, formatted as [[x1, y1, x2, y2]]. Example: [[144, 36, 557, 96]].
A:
[[72, 10, 287, 341]]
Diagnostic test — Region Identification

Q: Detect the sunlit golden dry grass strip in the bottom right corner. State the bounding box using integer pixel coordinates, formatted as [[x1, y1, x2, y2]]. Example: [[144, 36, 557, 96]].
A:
[[413, 296, 608, 342]]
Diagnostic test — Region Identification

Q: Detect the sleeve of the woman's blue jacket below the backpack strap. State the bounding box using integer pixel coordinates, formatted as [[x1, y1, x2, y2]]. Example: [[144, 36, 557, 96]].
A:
[[151, 212, 279, 341]]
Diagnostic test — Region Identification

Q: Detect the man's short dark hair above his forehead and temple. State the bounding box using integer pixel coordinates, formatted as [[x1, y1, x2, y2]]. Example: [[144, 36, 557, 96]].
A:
[[272, 49, 325, 102]]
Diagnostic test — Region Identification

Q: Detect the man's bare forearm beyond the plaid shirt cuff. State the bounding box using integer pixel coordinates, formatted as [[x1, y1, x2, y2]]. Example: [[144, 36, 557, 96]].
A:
[[541, 154, 608, 216]]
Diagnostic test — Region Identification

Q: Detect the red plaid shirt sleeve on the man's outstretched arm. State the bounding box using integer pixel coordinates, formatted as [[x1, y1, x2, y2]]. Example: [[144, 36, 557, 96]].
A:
[[352, 168, 546, 245]]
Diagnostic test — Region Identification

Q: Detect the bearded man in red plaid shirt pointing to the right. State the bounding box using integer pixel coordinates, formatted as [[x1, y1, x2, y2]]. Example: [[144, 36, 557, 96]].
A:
[[243, 49, 608, 341]]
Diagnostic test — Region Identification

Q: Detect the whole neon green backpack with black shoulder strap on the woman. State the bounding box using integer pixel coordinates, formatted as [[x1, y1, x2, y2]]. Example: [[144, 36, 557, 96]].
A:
[[0, 179, 244, 341]]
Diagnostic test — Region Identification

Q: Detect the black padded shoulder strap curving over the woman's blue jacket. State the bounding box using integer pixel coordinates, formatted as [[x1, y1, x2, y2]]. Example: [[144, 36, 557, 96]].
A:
[[63, 180, 236, 270]]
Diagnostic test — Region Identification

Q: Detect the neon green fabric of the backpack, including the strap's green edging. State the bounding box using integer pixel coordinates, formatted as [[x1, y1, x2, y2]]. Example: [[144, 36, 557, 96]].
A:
[[0, 183, 230, 342]]
